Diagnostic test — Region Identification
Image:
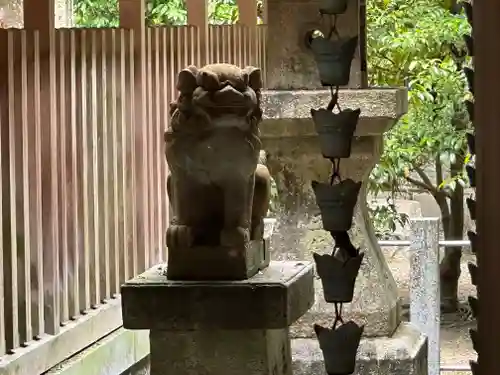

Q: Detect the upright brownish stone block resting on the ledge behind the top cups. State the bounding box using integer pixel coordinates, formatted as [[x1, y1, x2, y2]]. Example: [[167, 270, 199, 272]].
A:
[[266, 0, 366, 89]]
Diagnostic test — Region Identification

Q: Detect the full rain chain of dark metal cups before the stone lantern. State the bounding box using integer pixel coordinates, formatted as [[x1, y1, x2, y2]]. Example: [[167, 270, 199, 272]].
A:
[[308, 0, 364, 375]]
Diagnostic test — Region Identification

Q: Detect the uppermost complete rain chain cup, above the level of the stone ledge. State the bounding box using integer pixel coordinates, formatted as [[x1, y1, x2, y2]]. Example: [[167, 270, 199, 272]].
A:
[[310, 36, 358, 86]]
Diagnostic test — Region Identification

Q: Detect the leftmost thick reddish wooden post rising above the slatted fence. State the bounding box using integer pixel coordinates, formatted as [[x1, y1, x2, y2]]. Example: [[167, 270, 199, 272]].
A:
[[24, 0, 60, 334]]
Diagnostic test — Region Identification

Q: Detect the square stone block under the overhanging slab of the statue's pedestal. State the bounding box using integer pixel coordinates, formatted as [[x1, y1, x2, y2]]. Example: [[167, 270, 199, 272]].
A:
[[150, 328, 292, 375]]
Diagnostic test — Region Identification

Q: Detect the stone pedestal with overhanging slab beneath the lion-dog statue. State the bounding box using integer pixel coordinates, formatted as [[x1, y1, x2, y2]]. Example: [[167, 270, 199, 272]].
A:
[[122, 262, 314, 375]]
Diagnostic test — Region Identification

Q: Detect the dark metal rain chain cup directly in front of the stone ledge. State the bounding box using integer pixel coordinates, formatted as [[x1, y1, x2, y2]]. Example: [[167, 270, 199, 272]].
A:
[[311, 108, 361, 159]]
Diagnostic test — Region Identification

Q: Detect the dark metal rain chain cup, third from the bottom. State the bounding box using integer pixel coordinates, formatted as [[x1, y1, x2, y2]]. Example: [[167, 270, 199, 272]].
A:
[[311, 179, 361, 232]]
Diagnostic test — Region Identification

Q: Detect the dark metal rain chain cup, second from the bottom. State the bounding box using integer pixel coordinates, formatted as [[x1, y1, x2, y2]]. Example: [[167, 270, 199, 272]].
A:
[[313, 253, 365, 303]]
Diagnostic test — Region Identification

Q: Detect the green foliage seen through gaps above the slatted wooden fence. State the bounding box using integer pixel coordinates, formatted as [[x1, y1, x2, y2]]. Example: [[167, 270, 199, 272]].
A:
[[73, 0, 238, 27]]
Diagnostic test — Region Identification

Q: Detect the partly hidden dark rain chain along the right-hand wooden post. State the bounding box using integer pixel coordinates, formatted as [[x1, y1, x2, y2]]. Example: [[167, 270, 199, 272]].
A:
[[452, 1, 481, 375]]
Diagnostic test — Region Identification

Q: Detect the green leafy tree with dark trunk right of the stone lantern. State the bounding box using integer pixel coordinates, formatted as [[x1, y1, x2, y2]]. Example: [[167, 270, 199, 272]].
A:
[[367, 0, 470, 311]]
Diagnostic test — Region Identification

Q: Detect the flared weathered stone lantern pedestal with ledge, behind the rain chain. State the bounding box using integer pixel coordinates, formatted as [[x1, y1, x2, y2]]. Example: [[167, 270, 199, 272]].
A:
[[261, 89, 407, 337]]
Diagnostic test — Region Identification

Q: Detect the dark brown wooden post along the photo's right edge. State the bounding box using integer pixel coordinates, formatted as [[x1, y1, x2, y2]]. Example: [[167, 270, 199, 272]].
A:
[[473, 0, 500, 375]]
